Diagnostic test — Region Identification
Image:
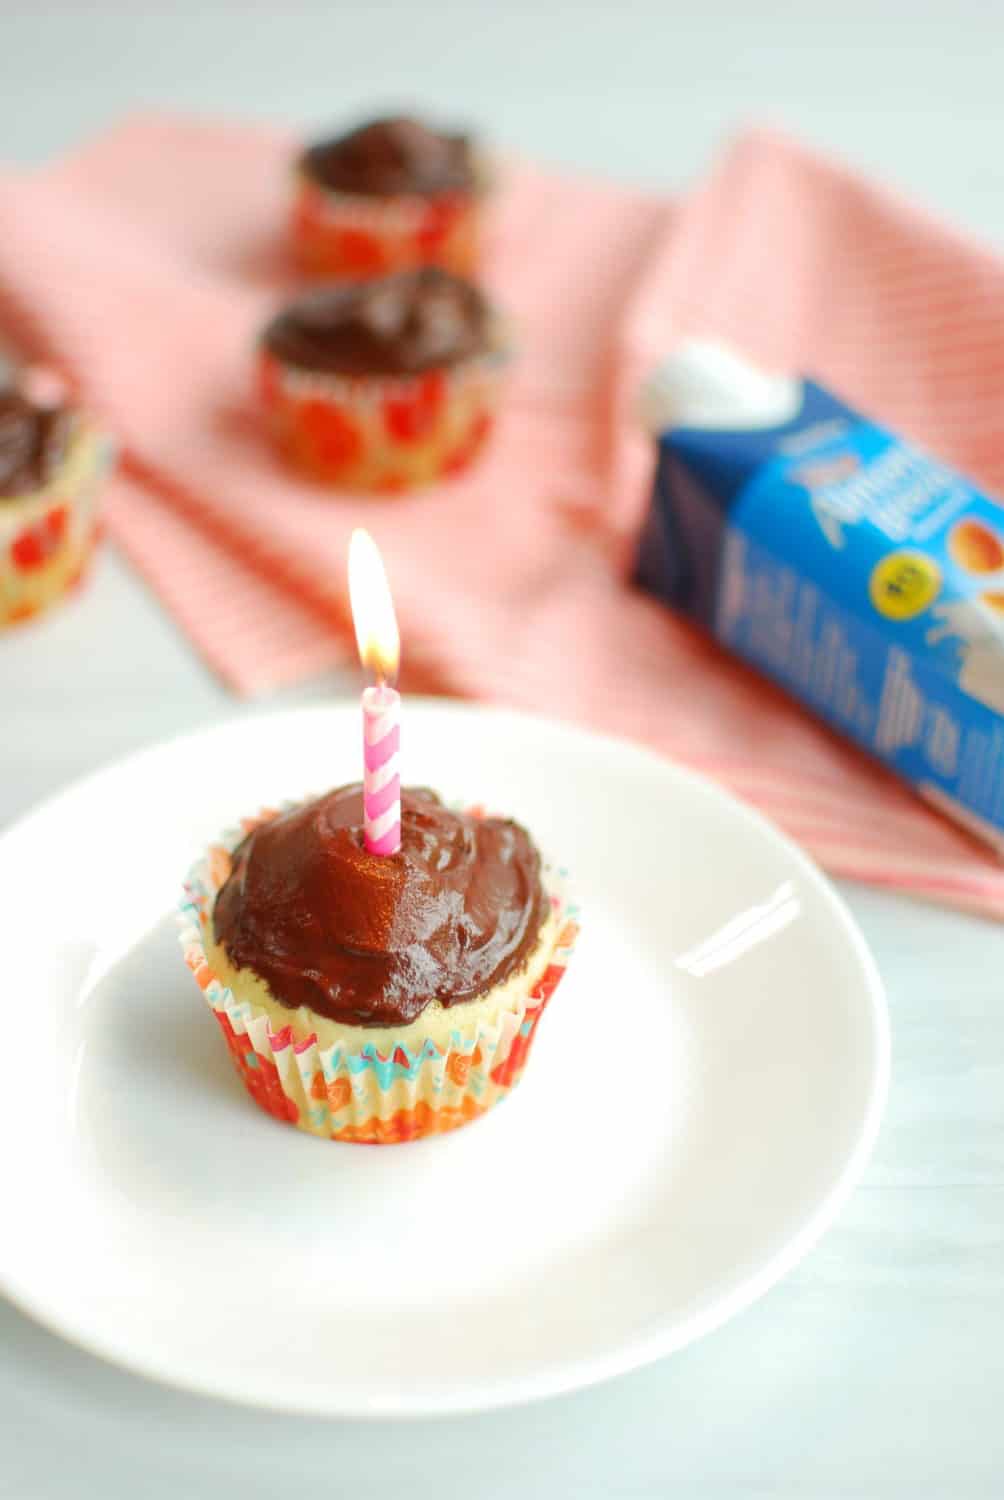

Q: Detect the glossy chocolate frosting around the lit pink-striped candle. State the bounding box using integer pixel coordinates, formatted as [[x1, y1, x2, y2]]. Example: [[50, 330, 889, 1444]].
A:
[[213, 783, 548, 1026]]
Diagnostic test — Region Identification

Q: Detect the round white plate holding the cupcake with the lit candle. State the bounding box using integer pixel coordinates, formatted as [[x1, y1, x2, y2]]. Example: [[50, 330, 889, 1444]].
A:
[[0, 702, 888, 1415]]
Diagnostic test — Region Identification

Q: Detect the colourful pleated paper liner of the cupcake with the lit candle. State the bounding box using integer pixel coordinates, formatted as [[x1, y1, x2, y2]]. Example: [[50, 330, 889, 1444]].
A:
[[180, 803, 578, 1145]]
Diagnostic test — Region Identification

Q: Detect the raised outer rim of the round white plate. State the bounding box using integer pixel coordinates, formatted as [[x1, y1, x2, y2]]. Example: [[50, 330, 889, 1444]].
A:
[[0, 695, 891, 1421]]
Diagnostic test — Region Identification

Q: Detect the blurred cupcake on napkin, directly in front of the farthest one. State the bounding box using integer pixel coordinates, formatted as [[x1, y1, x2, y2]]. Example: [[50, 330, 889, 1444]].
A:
[[258, 266, 506, 494]]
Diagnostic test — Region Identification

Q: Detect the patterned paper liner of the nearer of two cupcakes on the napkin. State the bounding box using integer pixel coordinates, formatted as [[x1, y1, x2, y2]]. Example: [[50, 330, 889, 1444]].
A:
[[258, 332, 509, 495]]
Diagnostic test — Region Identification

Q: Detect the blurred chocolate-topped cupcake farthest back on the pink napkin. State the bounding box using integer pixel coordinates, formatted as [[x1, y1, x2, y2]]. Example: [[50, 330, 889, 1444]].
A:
[[291, 119, 480, 278]]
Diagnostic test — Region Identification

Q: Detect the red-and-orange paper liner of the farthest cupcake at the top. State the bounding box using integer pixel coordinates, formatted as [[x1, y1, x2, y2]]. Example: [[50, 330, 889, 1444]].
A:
[[290, 171, 482, 281]]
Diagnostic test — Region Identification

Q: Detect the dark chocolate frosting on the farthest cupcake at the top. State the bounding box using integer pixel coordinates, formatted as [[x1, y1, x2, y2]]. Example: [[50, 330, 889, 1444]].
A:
[[300, 117, 474, 198]]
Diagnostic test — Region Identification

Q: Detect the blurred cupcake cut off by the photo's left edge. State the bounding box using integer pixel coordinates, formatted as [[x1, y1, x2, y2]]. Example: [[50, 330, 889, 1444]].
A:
[[0, 381, 108, 626]]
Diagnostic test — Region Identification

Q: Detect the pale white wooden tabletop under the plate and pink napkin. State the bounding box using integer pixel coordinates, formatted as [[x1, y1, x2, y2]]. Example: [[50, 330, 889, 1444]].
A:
[[0, 0, 1004, 1500]]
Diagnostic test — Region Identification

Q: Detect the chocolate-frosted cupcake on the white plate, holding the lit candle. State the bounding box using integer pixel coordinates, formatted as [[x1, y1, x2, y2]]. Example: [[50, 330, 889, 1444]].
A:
[[182, 785, 576, 1145]]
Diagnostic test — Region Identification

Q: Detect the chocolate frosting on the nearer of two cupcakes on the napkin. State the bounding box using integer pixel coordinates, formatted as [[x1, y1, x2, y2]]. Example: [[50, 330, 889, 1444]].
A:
[[263, 266, 491, 375]]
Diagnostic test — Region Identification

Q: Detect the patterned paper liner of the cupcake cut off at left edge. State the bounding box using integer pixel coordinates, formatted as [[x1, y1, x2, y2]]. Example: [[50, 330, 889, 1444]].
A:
[[0, 422, 113, 629]]
